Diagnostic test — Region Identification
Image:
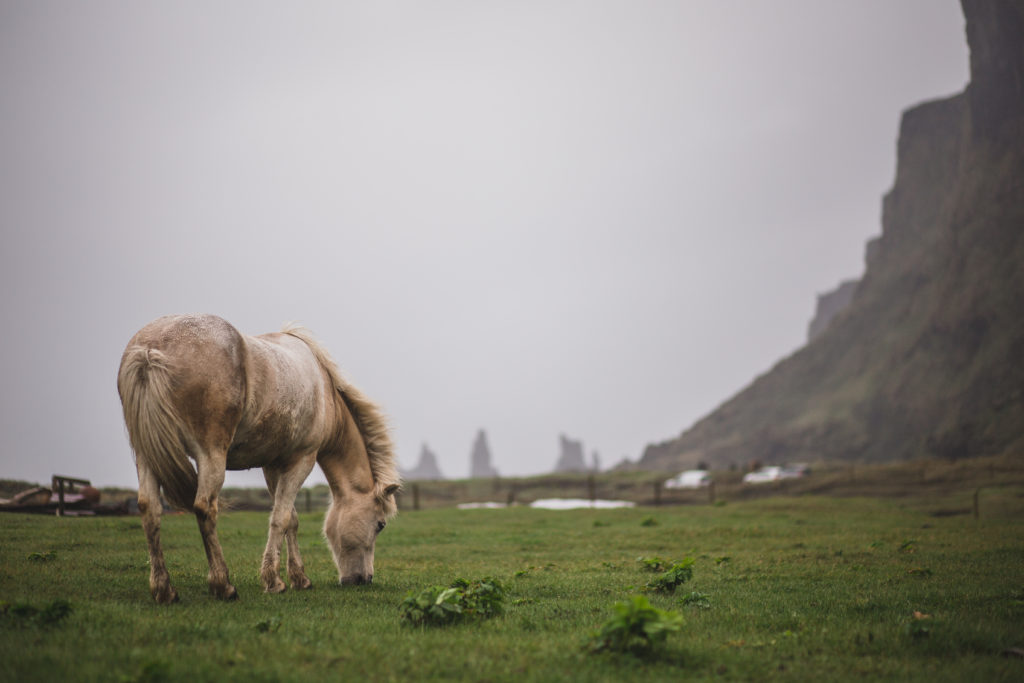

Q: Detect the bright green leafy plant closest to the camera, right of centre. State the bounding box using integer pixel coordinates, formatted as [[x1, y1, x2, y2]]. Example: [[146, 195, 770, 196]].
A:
[[586, 595, 683, 655]]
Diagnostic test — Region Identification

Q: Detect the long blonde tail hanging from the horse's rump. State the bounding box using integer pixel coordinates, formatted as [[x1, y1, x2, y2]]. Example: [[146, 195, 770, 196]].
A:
[[118, 346, 199, 510]]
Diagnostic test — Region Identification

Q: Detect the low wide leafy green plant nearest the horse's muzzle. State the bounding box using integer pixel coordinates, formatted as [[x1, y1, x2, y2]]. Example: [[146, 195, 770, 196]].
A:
[[400, 577, 505, 626]]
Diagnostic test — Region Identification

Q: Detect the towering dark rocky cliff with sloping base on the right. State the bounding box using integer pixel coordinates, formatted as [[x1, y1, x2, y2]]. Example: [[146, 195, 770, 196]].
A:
[[641, 0, 1024, 469]]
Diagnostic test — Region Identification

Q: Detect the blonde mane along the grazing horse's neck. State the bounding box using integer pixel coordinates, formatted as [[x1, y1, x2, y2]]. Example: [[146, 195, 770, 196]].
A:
[[281, 323, 401, 515]]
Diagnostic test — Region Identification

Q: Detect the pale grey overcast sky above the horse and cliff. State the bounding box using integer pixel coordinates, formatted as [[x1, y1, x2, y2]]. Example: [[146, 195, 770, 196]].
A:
[[0, 0, 968, 486]]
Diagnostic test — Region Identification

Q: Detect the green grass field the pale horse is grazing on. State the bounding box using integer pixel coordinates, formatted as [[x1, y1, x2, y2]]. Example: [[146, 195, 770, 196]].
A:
[[0, 486, 1024, 682]]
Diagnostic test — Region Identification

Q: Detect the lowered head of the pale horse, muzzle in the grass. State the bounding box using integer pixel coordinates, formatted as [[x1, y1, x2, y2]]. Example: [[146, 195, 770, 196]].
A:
[[324, 484, 398, 585]]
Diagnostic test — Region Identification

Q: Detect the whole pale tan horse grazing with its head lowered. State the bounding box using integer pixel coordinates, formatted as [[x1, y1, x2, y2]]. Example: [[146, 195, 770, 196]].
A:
[[118, 315, 400, 603]]
